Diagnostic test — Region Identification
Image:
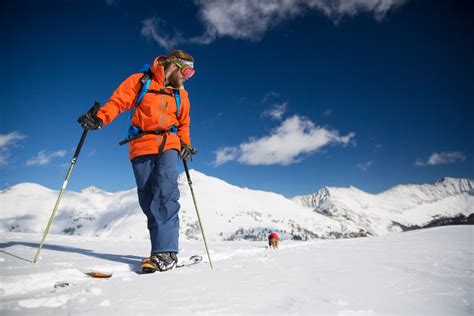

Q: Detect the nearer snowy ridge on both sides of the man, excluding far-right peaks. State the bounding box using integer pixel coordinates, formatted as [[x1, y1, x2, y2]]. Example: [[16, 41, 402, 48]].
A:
[[0, 170, 348, 240]]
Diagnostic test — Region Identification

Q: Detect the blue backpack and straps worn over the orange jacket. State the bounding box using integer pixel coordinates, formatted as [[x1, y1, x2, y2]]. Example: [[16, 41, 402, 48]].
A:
[[119, 64, 181, 147]]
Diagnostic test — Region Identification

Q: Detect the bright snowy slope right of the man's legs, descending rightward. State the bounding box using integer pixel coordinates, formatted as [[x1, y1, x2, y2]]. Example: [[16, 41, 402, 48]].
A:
[[180, 171, 341, 239]]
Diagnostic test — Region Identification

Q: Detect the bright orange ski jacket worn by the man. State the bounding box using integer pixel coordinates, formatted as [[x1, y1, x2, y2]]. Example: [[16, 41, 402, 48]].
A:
[[97, 58, 191, 160]]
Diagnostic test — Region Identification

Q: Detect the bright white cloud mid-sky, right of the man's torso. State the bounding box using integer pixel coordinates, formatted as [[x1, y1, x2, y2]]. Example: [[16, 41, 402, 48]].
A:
[[213, 115, 355, 166]]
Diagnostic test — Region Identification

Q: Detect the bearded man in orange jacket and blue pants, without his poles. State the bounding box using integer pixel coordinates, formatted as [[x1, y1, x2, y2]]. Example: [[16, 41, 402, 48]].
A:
[[78, 50, 196, 272]]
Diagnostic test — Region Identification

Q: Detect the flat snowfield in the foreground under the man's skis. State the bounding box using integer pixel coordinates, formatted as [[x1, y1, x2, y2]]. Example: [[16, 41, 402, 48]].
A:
[[0, 225, 474, 315]]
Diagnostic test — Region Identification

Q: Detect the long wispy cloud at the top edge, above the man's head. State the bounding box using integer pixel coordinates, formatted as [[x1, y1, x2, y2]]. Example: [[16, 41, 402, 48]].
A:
[[142, 0, 408, 49]]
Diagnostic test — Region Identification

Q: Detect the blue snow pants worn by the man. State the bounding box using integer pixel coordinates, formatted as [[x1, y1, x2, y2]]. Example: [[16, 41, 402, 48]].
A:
[[132, 150, 180, 254]]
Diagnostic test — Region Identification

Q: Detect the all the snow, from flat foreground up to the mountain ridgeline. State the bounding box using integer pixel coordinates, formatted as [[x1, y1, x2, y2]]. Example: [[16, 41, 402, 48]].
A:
[[0, 175, 474, 315]]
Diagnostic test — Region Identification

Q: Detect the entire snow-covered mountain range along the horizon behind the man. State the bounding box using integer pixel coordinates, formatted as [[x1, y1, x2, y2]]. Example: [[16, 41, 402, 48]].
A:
[[0, 170, 474, 240]]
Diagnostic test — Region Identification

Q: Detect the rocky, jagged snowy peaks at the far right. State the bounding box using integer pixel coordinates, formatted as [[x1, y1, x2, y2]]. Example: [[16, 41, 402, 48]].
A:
[[293, 178, 474, 235]]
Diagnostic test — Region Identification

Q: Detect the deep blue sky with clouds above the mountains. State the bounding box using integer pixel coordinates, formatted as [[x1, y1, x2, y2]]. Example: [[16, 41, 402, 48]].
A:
[[0, 0, 474, 196]]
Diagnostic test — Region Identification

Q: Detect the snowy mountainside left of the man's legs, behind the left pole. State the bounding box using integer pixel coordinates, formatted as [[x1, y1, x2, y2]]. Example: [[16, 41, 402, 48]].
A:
[[0, 183, 148, 238]]
